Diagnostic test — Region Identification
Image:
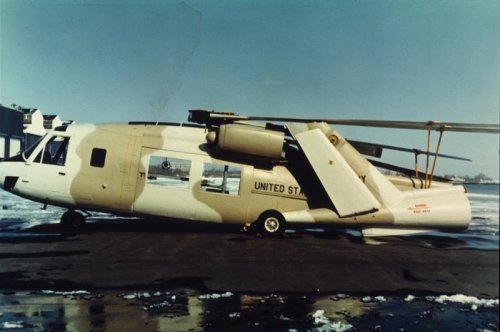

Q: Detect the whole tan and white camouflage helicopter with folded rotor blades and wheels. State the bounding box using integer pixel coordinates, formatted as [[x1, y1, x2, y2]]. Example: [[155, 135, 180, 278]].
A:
[[0, 110, 500, 236]]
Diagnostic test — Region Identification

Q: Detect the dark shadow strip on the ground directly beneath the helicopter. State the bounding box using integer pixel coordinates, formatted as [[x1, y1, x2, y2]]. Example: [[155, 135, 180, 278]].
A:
[[9, 217, 471, 249]]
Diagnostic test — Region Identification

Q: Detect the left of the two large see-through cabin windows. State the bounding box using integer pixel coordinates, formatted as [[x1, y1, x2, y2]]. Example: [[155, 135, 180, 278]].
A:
[[148, 156, 191, 188]]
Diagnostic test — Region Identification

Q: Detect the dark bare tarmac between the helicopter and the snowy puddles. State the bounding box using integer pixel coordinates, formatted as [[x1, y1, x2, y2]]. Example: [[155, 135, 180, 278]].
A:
[[0, 220, 499, 298]]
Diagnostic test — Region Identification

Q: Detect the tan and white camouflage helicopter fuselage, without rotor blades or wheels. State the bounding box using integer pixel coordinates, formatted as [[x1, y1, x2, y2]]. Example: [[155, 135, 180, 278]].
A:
[[0, 123, 470, 235]]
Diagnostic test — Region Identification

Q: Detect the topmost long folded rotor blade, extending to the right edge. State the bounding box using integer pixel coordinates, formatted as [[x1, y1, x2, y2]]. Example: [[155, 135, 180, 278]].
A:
[[189, 110, 500, 134]]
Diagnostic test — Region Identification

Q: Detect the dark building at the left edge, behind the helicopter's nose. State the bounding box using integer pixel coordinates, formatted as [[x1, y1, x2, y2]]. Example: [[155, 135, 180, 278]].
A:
[[0, 105, 24, 160]]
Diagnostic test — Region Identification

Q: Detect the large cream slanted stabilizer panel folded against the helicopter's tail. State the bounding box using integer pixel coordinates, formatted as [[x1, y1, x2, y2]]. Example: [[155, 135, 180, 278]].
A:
[[294, 129, 380, 217]]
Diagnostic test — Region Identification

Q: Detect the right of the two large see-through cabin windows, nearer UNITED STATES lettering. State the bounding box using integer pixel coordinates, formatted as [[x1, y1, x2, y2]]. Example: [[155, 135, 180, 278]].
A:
[[200, 163, 241, 195]]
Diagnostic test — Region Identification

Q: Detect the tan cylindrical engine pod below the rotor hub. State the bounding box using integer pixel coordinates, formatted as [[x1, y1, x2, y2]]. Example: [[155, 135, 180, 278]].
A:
[[207, 123, 285, 159]]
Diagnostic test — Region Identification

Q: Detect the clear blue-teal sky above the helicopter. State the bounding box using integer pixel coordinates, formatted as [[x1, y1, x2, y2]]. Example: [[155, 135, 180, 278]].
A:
[[0, 0, 500, 178]]
